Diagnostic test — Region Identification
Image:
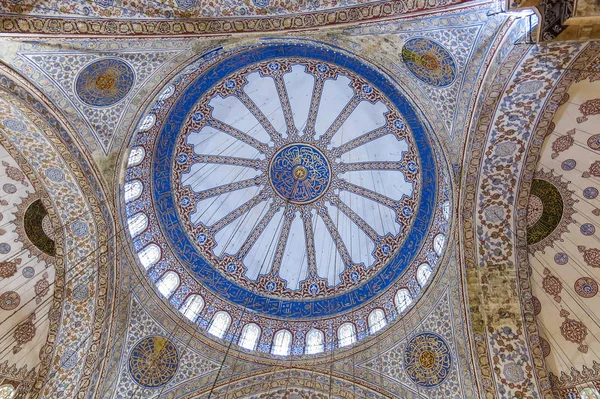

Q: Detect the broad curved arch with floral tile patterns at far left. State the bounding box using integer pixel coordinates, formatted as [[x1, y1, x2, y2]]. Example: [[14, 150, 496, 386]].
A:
[[0, 65, 114, 397]]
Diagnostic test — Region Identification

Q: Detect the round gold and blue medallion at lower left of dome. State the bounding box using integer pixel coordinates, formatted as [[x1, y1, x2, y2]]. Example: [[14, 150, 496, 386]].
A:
[[129, 336, 179, 388]]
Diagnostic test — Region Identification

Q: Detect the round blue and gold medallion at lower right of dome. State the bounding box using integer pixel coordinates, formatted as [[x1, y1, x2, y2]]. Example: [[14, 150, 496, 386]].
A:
[[404, 333, 452, 387]]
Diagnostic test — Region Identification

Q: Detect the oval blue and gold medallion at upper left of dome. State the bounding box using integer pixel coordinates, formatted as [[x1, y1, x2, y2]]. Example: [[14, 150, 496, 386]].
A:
[[75, 58, 135, 107]]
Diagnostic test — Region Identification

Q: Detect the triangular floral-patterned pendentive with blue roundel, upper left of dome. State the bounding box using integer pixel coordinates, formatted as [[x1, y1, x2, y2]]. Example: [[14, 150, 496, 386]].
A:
[[13, 46, 185, 154]]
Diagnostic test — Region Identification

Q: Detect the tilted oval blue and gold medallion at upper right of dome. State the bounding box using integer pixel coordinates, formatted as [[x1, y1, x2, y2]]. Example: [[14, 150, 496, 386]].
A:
[[402, 38, 456, 86]]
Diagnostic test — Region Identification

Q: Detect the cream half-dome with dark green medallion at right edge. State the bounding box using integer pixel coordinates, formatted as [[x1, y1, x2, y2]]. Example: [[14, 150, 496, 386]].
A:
[[527, 75, 600, 390]]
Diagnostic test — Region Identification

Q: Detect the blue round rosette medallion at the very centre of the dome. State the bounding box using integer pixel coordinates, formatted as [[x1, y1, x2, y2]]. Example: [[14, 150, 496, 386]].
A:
[[269, 144, 331, 204]]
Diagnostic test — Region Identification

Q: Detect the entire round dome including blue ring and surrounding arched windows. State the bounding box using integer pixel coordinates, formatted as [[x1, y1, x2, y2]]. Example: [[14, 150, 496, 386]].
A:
[[122, 42, 451, 356]]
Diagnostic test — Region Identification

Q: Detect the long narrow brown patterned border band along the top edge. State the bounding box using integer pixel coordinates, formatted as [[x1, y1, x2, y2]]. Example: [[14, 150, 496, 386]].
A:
[[0, 0, 469, 36]]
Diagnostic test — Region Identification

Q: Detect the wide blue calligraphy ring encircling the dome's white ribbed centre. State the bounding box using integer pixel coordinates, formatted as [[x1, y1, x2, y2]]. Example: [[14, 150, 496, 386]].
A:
[[152, 43, 438, 319]]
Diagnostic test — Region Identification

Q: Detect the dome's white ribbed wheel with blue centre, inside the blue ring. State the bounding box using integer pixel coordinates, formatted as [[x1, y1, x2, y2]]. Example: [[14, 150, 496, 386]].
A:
[[171, 51, 420, 302]]
